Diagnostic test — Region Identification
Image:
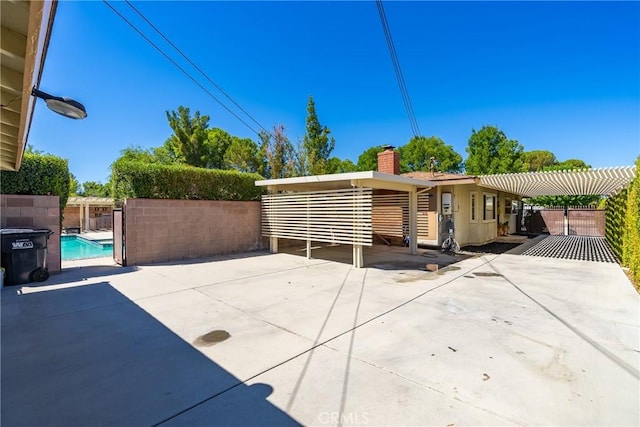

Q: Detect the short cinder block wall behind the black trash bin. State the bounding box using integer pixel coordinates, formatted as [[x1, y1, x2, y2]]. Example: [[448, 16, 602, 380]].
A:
[[0, 194, 62, 273]]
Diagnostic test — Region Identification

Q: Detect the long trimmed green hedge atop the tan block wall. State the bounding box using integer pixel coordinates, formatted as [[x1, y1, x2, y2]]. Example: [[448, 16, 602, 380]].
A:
[[111, 161, 263, 200]]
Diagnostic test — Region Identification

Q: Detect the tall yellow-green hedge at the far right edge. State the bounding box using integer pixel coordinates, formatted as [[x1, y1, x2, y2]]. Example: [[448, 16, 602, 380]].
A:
[[606, 157, 640, 286]]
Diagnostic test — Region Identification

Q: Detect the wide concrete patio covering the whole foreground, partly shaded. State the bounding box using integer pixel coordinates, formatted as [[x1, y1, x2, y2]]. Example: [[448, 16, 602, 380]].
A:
[[0, 252, 640, 426]]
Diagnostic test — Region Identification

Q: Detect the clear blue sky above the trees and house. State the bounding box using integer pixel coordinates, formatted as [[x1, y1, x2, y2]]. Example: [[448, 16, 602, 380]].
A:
[[29, 1, 640, 183]]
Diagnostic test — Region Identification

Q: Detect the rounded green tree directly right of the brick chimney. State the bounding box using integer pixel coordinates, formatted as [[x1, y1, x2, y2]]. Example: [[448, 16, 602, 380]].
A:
[[398, 136, 462, 172]]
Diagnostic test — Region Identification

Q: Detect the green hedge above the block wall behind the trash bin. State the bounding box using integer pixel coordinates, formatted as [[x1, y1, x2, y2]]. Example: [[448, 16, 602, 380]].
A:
[[0, 152, 69, 212]]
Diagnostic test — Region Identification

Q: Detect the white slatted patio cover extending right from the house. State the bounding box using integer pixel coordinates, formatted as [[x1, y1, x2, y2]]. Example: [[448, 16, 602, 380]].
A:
[[479, 166, 636, 197]]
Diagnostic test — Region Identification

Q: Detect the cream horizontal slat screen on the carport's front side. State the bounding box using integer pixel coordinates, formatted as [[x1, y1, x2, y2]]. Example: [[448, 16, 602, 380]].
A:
[[262, 188, 373, 246]]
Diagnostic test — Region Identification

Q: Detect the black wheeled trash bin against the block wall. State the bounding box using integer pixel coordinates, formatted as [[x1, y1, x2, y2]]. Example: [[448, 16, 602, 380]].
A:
[[0, 228, 53, 285]]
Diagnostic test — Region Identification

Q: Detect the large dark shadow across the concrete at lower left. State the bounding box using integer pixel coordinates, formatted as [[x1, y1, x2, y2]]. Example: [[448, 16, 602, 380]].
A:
[[0, 282, 298, 426]]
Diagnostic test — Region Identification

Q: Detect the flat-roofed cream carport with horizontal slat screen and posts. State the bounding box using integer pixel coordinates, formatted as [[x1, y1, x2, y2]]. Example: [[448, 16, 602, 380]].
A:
[[256, 171, 434, 268]]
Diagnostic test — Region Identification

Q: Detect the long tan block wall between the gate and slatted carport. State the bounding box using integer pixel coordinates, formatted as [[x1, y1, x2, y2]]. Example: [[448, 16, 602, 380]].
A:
[[125, 199, 262, 265]]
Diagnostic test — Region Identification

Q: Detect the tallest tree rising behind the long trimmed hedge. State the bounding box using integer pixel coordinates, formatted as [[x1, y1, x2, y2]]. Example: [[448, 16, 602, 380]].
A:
[[165, 106, 212, 167]]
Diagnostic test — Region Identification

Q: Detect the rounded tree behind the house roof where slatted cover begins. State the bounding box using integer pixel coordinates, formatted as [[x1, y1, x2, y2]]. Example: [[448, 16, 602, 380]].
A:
[[465, 126, 523, 175]]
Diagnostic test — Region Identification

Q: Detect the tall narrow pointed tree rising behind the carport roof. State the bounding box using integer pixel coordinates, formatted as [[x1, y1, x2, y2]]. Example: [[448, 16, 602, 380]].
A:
[[302, 96, 336, 175]]
